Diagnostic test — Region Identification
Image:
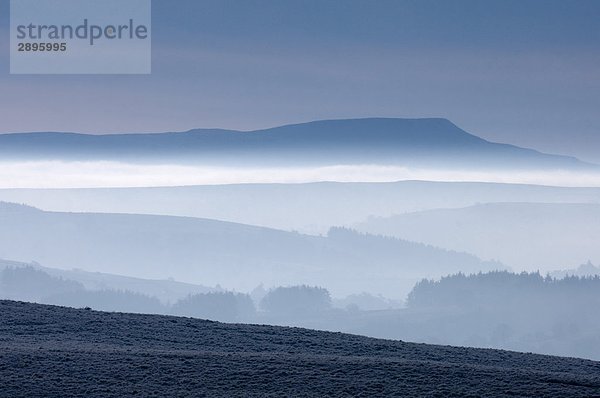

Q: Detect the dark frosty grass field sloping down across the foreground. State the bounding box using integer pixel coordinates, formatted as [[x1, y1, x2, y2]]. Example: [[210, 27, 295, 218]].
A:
[[0, 301, 600, 397]]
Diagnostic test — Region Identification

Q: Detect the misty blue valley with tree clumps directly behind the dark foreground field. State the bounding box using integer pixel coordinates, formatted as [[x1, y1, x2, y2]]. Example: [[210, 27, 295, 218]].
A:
[[0, 261, 600, 360]]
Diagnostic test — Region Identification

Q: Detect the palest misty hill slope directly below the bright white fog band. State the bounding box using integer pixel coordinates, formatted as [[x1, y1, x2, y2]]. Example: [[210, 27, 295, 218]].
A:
[[0, 181, 600, 234]]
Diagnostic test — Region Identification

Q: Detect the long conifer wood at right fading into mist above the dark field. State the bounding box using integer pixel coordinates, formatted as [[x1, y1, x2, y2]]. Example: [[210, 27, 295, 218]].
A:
[[394, 272, 600, 359]]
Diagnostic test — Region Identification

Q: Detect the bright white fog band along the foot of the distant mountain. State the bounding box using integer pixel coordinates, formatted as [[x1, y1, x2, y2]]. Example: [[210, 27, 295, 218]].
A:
[[0, 160, 600, 189]]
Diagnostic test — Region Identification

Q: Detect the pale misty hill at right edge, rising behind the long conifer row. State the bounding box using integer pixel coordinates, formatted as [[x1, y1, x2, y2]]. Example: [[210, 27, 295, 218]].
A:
[[356, 203, 600, 270]]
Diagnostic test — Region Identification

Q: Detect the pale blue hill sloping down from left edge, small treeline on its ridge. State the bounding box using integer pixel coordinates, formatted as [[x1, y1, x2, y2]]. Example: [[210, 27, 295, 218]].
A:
[[0, 203, 502, 298]]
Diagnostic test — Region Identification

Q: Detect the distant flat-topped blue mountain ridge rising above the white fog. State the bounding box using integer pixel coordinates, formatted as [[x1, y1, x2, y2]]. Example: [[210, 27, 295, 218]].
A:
[[0, 118, 600, 170]]
